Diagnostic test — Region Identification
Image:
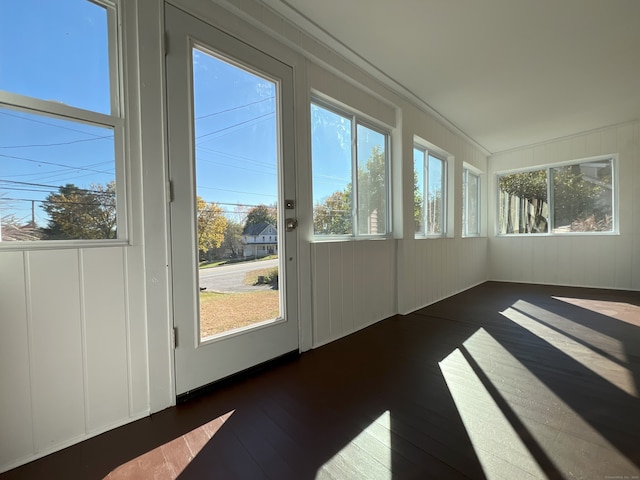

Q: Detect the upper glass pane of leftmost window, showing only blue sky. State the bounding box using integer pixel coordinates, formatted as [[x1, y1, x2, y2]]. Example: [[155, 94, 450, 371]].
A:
[[0, 0, 111, 114]]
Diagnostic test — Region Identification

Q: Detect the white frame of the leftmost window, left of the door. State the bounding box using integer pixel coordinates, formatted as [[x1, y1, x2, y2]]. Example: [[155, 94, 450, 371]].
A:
[[0, 0, 130, 251]]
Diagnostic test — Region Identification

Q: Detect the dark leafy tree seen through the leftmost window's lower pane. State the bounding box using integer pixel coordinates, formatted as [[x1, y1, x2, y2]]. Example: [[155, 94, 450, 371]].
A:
[[42, 181, 116, 240]]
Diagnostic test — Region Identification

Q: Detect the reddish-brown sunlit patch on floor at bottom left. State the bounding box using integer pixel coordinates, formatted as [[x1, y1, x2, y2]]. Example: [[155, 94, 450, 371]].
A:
[[104, 410, 235, 480]]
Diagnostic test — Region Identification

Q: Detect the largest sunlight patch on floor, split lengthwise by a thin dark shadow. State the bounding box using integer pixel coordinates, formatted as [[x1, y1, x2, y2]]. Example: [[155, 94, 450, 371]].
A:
[[440, 329, 637, 479]]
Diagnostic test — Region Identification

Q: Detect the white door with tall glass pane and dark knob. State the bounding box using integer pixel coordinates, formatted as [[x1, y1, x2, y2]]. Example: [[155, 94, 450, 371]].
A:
[[166, 5, 298, 395]]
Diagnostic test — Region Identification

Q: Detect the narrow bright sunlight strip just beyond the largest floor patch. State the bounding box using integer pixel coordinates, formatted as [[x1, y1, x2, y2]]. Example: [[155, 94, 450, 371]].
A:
[[500, 302, 638, 397]]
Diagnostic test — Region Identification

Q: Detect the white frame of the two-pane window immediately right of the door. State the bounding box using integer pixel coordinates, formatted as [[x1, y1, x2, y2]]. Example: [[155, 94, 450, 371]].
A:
[[309, 96, 393, 238]]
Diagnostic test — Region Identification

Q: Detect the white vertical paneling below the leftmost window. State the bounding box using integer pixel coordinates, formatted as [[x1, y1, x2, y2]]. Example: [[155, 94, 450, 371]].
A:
[[0, 247, 148, 471]]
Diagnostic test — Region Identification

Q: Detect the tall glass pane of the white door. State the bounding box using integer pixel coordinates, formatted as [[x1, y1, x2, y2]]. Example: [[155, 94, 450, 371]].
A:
[[192, 47, 282, 341]]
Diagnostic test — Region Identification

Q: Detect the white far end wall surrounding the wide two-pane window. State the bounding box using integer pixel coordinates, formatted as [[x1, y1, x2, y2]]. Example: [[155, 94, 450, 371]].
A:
[[489, 123, 640, 290]]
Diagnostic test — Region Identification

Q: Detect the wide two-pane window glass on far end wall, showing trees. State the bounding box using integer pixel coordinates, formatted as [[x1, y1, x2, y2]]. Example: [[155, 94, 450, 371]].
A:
[[498, 157, 614, 234]]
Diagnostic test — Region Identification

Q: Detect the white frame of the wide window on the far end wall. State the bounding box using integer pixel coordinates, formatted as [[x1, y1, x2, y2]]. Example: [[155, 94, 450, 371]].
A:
[[495, 154, 620, 238]]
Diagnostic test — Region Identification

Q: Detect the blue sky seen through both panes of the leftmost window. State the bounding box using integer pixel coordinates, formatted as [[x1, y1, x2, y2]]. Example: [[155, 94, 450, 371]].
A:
[[0, 0, 114, 225]]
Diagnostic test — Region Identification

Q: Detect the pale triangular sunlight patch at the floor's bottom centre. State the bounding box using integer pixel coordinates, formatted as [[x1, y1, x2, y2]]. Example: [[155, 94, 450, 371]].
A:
[[316, 410, 393, 480]]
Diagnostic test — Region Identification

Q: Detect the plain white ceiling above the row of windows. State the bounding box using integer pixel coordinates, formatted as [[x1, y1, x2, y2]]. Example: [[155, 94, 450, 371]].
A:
[[264, 0, 640, 153]]
